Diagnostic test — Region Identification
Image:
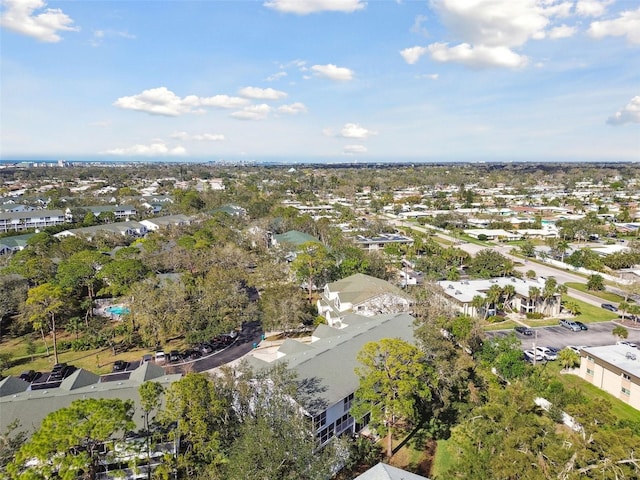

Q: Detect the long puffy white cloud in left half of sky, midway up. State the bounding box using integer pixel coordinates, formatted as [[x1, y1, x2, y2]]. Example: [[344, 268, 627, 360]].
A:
[[113, 87, 248, 117]]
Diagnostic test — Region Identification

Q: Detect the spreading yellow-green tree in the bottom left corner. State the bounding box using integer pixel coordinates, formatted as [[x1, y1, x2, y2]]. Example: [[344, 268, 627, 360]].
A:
[[9, 398, 135, 480]]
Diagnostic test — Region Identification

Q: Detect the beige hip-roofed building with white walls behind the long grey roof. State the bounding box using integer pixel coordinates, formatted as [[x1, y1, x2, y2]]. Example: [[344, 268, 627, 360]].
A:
[[317, 273, 411, 326]]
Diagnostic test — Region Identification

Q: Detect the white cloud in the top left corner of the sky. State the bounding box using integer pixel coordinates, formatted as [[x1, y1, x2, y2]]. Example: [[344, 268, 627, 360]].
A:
[[0, 0, 80, 43]]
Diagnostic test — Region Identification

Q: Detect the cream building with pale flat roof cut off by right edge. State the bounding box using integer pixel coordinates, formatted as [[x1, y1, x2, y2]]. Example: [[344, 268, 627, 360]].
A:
[[580, 345, 640, 410]]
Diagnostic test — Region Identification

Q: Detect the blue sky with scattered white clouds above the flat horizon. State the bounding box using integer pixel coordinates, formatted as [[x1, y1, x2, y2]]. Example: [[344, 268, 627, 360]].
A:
[[0, 0, 640, 162]]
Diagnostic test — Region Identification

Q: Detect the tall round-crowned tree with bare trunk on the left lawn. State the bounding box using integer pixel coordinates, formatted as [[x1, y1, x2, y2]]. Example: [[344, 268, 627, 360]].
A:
[[26, 283, 66, 363]]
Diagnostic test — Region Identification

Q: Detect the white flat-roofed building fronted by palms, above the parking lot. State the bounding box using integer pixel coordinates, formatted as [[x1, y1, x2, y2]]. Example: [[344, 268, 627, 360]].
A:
[[438, 277, 561, 317]]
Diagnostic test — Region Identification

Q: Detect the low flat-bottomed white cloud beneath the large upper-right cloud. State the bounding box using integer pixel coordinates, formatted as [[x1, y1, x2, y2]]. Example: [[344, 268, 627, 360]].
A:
[[429, 43, 528, 68]]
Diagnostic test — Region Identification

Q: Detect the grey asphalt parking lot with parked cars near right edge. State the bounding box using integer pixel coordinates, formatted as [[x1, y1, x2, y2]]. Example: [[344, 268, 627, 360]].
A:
[[487, 322, 640, 350]]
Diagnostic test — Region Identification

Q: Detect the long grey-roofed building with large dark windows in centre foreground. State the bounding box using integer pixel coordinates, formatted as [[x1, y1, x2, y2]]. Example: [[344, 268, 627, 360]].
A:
[[247, 313, 415, 445]]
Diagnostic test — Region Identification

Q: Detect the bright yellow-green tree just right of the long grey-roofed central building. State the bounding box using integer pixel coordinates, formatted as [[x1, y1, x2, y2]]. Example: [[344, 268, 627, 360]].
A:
[[351, 338, 431, 457]]
